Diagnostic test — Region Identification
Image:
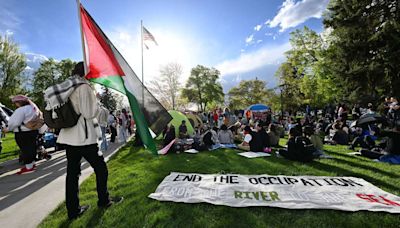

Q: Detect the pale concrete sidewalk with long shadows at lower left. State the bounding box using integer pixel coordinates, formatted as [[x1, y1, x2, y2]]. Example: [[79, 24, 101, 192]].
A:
[[0, 138, 129, 228]]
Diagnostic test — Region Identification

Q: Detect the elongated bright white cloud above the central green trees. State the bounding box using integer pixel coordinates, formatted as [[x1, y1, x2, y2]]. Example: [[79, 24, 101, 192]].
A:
[[216, 43, 290, 76]]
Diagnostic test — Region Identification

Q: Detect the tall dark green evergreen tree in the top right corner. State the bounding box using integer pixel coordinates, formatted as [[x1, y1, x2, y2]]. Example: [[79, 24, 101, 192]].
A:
[[324, 0, 400, 103]]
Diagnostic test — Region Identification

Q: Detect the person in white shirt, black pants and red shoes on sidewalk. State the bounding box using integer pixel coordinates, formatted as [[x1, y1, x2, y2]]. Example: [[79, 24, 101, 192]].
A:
[[6, 95, 40, 175]]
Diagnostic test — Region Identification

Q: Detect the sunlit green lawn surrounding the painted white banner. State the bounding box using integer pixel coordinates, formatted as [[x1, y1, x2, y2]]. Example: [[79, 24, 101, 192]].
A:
[[40, 139, 400, 227]]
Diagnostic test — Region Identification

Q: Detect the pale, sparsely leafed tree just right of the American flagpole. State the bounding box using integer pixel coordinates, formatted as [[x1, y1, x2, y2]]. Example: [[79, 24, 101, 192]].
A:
[[150, 63, 182, 110]]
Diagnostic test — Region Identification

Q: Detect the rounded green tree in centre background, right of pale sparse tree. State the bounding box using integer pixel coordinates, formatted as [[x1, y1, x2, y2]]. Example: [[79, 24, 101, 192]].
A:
[[182, 65, 224, 112]]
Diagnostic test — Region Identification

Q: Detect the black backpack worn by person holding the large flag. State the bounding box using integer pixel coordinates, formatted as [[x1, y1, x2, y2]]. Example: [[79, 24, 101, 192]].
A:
[[43, 99, 81, 129]]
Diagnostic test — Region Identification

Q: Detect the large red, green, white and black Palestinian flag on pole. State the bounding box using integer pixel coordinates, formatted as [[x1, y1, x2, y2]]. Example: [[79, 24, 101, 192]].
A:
[[80, 5, 172, 153]]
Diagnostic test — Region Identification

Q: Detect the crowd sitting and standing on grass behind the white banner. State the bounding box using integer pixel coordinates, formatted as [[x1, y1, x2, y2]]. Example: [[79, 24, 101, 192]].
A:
[[163, 100, 400, 163]]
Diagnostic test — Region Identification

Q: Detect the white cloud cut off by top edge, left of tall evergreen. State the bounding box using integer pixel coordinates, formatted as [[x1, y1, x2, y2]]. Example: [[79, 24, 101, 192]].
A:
[[265, 0, 329, 32]]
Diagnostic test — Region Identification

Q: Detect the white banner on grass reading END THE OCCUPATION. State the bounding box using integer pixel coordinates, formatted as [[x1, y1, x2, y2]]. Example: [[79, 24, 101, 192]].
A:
[[149, 173, 400, 213]]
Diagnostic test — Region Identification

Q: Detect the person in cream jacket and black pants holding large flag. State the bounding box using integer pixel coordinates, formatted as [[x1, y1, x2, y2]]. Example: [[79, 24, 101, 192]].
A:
[[45, 62, 123, 220]]
